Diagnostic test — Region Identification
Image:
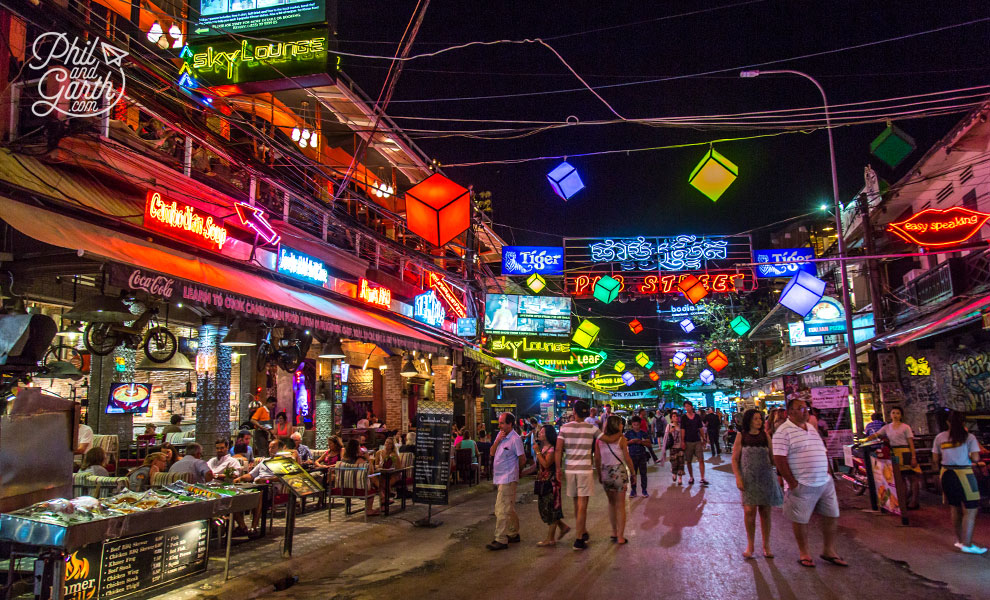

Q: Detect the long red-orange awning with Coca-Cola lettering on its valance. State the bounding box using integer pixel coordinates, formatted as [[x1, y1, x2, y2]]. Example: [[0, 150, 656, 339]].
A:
[[0, 197, 448, 352]]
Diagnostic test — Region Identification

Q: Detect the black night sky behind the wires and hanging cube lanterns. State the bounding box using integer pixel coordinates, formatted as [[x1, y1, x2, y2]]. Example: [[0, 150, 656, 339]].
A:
[[338, 0, 990, 244]]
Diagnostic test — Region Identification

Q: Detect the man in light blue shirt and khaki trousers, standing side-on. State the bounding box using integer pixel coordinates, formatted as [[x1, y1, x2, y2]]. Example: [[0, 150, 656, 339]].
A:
[[485, 413, 526, 550]]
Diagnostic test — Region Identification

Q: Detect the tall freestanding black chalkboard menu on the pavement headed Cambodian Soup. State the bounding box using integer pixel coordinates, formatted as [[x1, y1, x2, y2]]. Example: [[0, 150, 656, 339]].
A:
[[413, 402, 454, 504]]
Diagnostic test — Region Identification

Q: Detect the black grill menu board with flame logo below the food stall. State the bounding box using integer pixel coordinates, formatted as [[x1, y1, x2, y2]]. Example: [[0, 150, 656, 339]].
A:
[[65, 521, 210, 600]]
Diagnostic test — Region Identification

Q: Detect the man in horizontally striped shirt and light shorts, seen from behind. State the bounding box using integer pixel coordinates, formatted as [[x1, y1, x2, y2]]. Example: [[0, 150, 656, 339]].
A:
[[554, 400, 602, 550]]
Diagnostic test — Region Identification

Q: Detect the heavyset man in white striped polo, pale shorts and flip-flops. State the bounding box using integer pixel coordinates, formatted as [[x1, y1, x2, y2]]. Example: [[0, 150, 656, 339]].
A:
[[773, 398, 849, 567]]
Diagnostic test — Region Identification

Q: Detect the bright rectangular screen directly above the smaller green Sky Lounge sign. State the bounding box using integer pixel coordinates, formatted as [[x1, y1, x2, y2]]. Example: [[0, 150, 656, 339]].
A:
[[485, 294, 571, 337]]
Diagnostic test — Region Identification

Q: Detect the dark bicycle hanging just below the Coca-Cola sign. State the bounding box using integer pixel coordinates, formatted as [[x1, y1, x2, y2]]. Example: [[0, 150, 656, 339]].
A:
[[83, 306, 179, 363]]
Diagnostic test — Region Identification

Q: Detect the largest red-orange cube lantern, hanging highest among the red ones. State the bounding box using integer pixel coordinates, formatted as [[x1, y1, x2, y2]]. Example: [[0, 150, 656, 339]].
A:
[[406, 173, 471, 246]]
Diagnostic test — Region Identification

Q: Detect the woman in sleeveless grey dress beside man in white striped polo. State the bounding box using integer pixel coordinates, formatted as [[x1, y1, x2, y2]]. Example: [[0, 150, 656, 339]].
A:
[[732, 408, 784, 559]]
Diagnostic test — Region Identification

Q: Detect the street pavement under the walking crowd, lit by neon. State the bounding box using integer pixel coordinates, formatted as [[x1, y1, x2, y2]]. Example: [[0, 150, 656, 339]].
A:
[[256, 455, 990, 600]]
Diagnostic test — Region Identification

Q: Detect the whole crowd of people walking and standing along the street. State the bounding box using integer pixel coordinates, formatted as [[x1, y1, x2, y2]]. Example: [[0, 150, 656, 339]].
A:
[[487, 398, 986, 568]]
